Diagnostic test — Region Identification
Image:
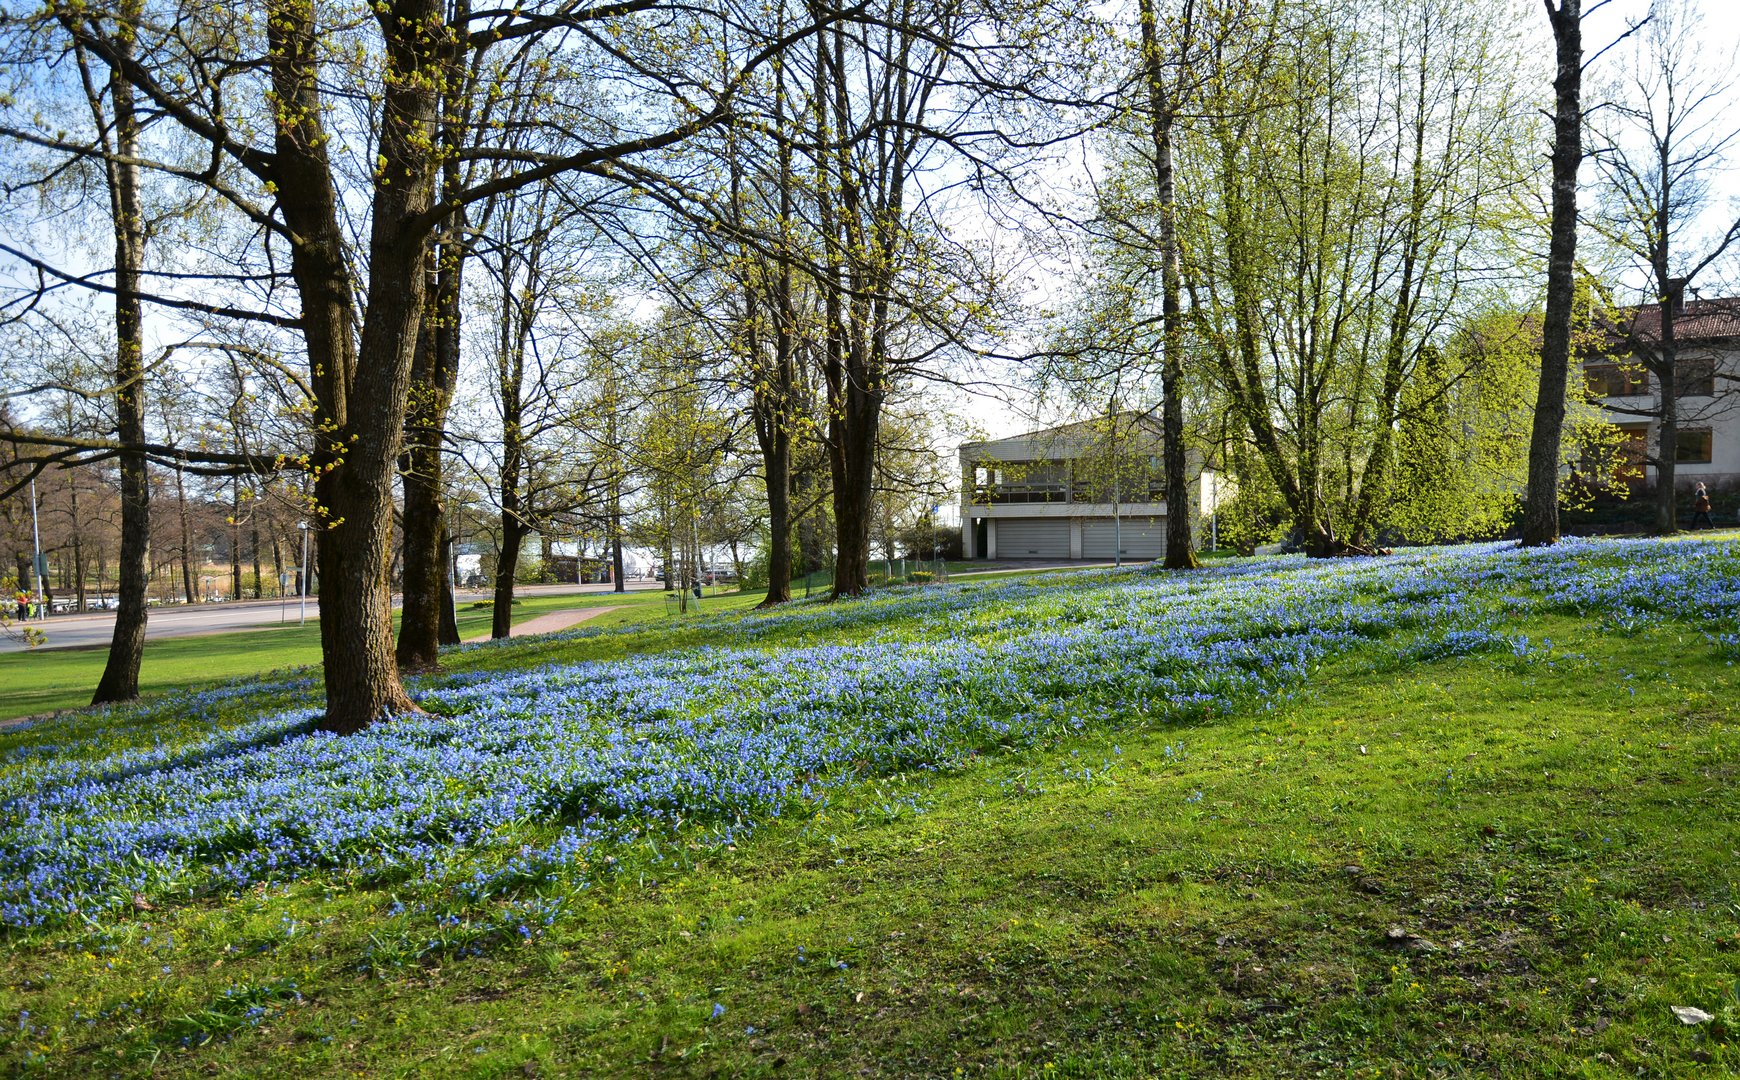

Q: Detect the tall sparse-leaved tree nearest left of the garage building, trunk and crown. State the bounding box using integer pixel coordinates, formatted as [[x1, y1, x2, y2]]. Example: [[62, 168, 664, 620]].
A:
[[806, 0, 1001, 597]]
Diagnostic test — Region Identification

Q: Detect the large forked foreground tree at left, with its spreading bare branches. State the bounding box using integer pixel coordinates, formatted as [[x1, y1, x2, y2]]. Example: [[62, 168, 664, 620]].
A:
[[22, 0, 837, 732]]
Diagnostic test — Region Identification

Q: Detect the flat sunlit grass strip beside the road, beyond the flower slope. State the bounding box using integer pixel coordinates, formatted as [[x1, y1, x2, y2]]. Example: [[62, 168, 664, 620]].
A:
[[0, 591, 759, 720]]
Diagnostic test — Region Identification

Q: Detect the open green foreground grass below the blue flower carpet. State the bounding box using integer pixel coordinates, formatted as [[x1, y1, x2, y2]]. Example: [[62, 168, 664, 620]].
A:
[[0, 591, 1740, 1077]]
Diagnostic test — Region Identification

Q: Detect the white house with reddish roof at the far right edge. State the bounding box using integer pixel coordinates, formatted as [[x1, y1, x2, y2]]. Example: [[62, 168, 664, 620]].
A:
[[1583, 299, 1740, 490]]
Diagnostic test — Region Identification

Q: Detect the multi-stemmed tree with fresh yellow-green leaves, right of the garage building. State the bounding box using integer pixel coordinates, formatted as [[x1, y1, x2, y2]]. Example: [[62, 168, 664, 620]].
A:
[[1183, 0, 1526, 555]]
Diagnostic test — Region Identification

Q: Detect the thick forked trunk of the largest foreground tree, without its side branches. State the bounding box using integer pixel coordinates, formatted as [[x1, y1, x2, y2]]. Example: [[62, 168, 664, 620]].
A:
[[266, 0, 447, 734]]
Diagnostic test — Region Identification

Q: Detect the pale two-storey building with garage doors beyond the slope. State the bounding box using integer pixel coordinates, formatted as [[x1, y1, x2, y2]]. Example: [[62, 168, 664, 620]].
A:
[[960, 412, 1232, 562]]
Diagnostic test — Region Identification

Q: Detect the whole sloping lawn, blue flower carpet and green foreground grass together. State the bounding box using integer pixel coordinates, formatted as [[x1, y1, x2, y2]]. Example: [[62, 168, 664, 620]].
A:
[[0, 541, 1740, 1077]]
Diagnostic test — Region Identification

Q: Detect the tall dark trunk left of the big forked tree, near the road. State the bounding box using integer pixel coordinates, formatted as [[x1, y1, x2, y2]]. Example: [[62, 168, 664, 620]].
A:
[[90, 21, 149, 704]]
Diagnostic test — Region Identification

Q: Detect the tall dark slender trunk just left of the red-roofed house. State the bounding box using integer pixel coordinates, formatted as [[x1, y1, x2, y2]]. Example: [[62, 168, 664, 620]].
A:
[[1523, 0, 1583, 548]]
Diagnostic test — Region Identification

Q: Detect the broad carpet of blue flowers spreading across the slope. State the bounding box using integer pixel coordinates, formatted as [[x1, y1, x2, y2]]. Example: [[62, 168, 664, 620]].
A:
[[0, 541, 1740, 934]]
